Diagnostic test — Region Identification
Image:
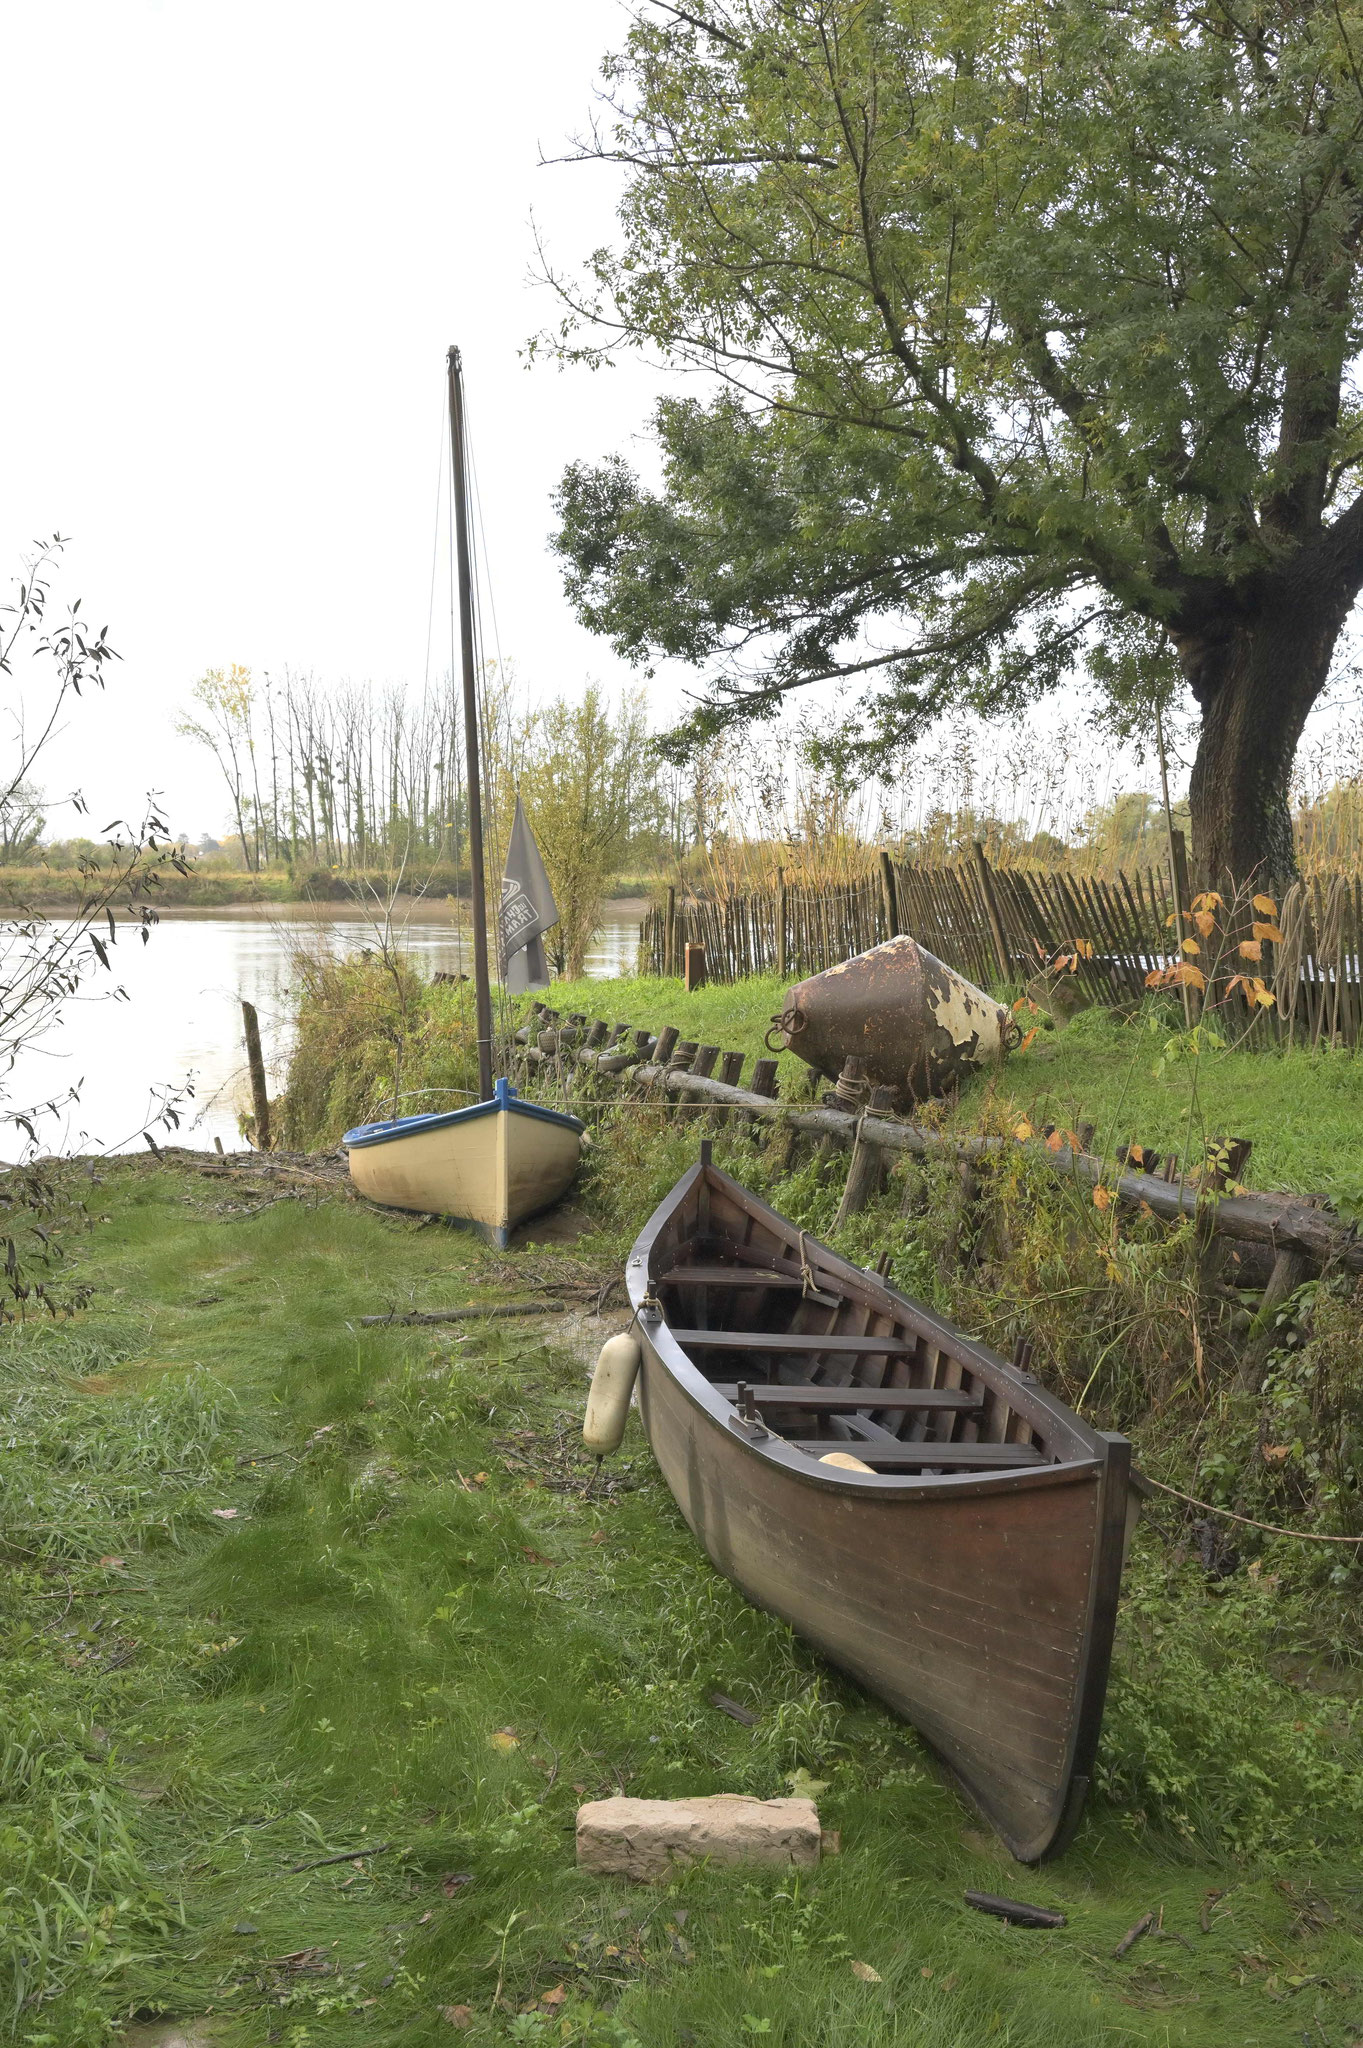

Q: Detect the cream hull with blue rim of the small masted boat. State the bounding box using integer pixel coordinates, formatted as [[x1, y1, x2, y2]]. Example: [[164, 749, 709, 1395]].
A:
[[342, 1081, 583, 1245]]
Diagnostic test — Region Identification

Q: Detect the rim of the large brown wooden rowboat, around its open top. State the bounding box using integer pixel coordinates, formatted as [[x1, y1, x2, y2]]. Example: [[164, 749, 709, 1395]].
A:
[[626, 1161, 1107, 1501]]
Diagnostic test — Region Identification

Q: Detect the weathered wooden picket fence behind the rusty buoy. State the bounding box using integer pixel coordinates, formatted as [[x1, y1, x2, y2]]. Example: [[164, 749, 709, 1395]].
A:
[[639, 848, 1363, 1044]]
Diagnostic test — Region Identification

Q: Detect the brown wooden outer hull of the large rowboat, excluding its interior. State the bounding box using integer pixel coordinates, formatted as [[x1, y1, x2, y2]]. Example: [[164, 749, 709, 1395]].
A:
[[628, 1167, 1128, 1862]]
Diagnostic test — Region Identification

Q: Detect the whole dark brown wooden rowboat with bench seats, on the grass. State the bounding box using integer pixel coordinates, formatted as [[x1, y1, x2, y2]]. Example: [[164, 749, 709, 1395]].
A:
[[626, 1157, 1130, 1864]]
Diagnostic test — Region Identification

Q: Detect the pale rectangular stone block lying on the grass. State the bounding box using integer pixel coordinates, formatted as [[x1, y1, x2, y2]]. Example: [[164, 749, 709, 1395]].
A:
[[577, 1792, 819, 1884]]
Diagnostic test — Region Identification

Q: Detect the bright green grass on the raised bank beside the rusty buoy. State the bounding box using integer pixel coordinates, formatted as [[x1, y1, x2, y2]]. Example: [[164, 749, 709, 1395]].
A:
[[548, 977, 1363, 1210]]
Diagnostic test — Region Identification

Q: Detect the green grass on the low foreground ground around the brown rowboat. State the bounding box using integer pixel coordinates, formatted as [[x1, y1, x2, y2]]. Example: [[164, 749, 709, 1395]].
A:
[[0, 1163, 1363, 2048]]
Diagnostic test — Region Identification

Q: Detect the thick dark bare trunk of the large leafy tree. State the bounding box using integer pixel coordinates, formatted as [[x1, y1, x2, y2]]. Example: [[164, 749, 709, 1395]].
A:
[[1173, 592, 1349, 887]]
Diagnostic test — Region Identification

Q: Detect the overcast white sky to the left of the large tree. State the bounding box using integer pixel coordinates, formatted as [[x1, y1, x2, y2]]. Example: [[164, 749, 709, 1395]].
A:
[[0, 0, 667, 831]]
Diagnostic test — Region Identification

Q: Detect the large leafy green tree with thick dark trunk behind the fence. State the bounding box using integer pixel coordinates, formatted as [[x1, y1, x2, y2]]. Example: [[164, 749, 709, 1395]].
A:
[[557, 0, 1363, 877]]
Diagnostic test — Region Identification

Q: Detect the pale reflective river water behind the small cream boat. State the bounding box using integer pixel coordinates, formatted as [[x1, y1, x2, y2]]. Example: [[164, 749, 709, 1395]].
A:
[[2, 901, 645, 1157]]
